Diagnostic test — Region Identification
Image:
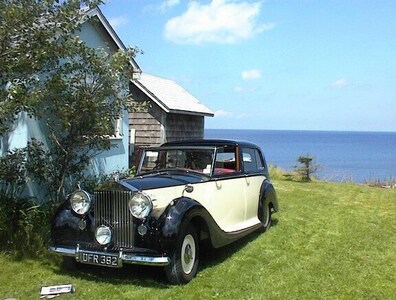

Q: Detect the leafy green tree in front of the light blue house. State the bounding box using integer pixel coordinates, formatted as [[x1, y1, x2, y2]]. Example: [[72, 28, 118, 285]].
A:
[[0, 0, 139, 202]]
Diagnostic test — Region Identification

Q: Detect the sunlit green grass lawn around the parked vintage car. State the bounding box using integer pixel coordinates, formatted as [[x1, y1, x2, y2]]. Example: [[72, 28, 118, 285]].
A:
[[0, 180, 396, 299]]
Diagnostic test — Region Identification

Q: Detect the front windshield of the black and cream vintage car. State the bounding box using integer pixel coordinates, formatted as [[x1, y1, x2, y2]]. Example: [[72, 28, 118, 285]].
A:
[[139, 148, 215, 175]]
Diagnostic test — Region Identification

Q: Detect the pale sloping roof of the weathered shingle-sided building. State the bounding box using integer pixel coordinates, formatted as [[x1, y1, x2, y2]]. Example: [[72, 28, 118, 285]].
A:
[[132, 72, 214, 117]]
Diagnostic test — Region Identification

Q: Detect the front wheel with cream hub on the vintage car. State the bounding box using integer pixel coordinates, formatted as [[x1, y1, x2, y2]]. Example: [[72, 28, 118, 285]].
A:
[[165, 225, 199, 284]]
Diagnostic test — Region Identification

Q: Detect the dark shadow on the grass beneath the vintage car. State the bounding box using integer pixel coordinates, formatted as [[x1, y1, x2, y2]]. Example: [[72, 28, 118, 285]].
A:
[[48, 219, 278, 289]]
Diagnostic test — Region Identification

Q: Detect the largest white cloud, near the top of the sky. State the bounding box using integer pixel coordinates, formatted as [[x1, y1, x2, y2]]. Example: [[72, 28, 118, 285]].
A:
[[164, 0, 274, 44]]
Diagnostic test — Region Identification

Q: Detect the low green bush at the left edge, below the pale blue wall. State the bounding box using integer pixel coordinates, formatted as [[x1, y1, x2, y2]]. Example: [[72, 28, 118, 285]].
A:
[[0, 140, 53, 258]]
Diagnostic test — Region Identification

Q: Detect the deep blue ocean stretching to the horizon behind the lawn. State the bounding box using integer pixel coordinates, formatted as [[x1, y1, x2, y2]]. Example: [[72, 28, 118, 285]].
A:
[[205, 129, 396, 183]]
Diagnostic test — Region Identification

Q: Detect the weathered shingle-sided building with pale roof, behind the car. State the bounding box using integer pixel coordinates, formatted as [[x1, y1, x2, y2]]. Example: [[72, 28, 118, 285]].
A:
[[129, 72, 214, 152]]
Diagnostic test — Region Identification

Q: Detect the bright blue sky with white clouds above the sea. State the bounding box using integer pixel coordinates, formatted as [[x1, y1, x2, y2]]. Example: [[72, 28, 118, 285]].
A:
[[101, 0, 396, 131]]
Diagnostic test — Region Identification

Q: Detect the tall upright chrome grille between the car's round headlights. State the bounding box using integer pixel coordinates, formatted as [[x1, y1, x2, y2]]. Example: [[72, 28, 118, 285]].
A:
[[94, 191, 133, 248]]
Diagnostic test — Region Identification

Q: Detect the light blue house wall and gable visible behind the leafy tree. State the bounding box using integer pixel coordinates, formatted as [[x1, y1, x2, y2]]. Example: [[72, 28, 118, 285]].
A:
[[0, 8, 141, 196]]
